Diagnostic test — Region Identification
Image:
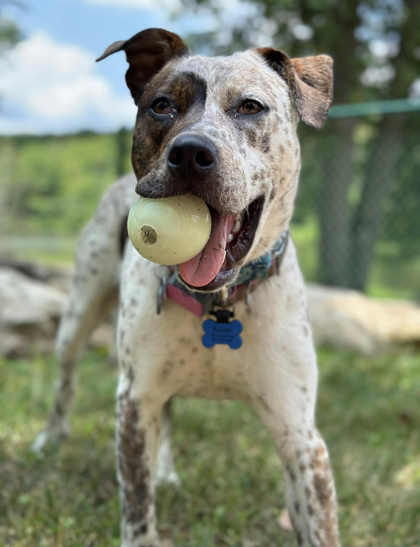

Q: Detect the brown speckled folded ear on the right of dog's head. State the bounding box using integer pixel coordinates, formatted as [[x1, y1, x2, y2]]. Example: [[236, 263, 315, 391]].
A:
[[256, 48, 333, 129]]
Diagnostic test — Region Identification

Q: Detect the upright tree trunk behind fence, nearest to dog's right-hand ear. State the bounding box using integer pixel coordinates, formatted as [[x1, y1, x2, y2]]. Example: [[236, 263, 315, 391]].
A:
[[318, 2, 359, 287]]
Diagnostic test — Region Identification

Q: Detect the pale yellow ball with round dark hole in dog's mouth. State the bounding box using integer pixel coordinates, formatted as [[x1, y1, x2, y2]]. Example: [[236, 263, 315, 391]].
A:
[[127, 194, 211, 266]]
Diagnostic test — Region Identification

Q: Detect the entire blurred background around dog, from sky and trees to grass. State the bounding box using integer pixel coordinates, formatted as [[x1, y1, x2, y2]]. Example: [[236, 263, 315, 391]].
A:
[[0, 0, 420, 547]]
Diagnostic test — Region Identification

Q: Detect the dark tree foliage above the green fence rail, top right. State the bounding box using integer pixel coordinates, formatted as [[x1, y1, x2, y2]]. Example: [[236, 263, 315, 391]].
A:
[[183, 0, 420, 103]]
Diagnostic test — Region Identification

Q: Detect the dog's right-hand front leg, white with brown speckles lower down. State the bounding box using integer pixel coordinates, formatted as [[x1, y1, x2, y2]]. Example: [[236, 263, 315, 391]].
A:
[[249, 341, 340, 547]]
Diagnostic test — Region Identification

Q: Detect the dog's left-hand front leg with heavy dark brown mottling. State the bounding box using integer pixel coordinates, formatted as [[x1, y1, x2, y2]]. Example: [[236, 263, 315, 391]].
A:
[[117, 373, 162, 547]]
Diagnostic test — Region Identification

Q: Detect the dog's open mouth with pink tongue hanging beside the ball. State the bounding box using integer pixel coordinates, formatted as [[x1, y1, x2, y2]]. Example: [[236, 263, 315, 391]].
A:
[[178, 197, 263, 291]]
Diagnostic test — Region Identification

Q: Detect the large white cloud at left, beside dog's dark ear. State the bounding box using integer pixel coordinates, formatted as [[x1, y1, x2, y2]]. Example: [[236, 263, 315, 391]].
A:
[[0, 33, 136, 134]]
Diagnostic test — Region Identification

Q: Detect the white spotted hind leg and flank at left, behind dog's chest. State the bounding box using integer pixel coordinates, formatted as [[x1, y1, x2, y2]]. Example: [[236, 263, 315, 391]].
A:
[[33, 177, 134, 452]]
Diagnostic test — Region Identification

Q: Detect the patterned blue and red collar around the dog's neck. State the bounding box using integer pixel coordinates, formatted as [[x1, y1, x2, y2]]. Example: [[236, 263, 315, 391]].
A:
[[156, 230, 289, 317]]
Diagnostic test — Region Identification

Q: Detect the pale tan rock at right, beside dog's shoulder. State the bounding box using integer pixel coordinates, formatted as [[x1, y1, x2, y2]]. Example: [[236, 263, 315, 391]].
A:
[[308, 285, 420, 354]]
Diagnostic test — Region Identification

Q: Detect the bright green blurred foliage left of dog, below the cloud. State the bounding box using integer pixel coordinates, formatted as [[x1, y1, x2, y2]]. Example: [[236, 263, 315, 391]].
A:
[[0, 132, 130, 235]]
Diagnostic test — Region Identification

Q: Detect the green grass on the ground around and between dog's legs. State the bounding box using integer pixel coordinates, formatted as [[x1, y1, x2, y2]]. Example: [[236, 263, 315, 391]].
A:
[[0, 350, 420, 547]]
